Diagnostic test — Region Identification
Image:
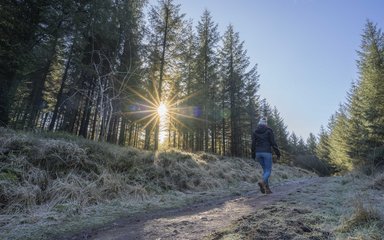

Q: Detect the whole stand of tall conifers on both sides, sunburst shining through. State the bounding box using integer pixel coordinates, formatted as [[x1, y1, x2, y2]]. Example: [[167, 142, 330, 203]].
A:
[[0, 0, 384, 172]]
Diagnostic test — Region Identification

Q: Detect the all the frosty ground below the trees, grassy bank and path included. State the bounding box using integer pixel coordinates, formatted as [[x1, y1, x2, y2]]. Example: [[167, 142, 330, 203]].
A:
[[0, 128, 384, 239]]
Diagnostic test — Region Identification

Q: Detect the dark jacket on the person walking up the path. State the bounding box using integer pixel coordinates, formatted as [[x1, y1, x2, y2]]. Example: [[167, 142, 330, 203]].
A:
[[252, 125, 280, 159]]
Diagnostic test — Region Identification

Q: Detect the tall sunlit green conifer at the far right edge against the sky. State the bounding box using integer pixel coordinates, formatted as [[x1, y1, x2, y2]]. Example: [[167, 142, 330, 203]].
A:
[[349, 21, 384, 164]]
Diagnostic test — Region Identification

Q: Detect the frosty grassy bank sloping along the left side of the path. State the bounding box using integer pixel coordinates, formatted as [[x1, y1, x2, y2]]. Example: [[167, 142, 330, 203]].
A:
[[0, 128, 314, 239]]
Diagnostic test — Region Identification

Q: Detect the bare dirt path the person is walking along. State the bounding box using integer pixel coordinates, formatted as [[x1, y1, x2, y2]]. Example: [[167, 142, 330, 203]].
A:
[[61, 178, 320, 240]]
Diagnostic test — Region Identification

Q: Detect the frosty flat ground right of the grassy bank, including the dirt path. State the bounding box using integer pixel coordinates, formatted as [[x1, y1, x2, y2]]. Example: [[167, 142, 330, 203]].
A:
[[59, 176, 384, 240]]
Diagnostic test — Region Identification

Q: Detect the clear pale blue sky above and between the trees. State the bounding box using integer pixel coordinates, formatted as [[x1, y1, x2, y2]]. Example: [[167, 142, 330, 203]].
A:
[[151, 0, 384, 140]]
